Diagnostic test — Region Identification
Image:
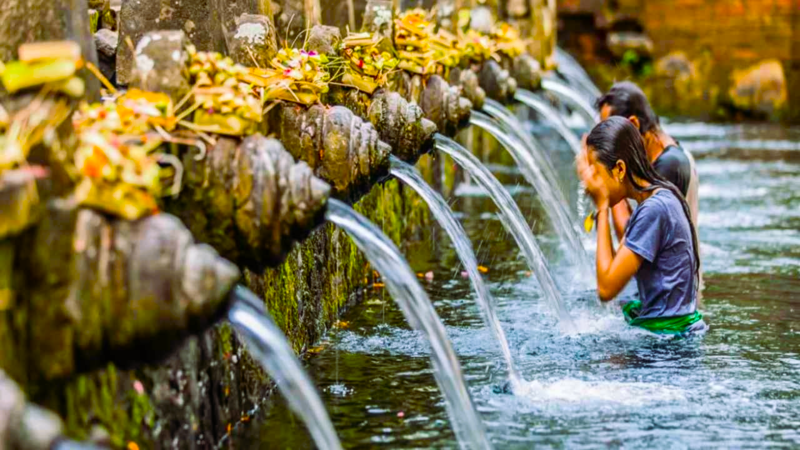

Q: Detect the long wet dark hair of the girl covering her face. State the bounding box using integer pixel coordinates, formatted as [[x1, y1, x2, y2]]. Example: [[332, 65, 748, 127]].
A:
[[586, 117, 700, 289]]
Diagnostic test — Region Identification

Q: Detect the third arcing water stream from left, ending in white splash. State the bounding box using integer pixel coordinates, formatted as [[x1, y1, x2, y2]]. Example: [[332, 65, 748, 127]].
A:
[[390, 156, 521, 389]]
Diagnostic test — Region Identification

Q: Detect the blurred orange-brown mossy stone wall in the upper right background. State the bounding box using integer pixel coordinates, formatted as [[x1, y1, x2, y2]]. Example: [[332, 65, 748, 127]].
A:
[[558, 0, 800, 121]]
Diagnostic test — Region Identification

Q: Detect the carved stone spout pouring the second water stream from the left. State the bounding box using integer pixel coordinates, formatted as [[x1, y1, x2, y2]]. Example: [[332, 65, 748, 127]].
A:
[[168, 135, 330, 270]]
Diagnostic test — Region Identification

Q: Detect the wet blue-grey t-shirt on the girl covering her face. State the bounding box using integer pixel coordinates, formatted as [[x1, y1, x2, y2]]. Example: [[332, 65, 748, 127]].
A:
[[625, 189, 697, 319]]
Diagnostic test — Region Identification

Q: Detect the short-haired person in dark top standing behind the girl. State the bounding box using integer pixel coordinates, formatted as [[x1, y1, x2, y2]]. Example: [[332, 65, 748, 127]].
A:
[[595, 81, 699, 239]]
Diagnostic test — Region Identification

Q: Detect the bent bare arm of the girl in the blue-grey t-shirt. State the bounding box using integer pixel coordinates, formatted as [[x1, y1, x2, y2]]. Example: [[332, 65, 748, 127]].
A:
[[597, 206, 642, 302]]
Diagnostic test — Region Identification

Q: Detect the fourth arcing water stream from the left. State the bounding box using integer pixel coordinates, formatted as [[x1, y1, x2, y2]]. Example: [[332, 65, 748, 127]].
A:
[[434, 134, 575, 332]]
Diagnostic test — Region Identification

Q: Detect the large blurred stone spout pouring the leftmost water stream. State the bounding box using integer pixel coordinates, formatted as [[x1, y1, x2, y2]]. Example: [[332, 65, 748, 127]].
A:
[[0, 199, 239, 381]]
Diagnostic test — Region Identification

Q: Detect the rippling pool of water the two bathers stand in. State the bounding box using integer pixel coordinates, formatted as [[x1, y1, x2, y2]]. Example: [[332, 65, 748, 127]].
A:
[[244, 124, 800, 448]]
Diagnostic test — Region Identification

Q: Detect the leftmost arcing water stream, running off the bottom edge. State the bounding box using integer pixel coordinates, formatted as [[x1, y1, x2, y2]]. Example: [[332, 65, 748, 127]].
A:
[[228, 286, 342, 450]]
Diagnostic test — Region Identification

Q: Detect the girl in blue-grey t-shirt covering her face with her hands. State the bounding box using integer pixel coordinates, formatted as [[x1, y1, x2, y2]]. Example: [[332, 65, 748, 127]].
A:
[[576, 117, 707, 334]]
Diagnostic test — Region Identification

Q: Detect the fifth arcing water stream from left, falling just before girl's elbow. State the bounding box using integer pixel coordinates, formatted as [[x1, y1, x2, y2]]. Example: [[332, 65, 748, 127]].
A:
[[469, 108, 594, 281]]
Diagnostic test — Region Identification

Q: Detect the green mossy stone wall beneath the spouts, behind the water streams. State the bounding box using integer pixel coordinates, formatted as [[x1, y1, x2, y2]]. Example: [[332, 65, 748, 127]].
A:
[[20, 156, 433, 449]]
